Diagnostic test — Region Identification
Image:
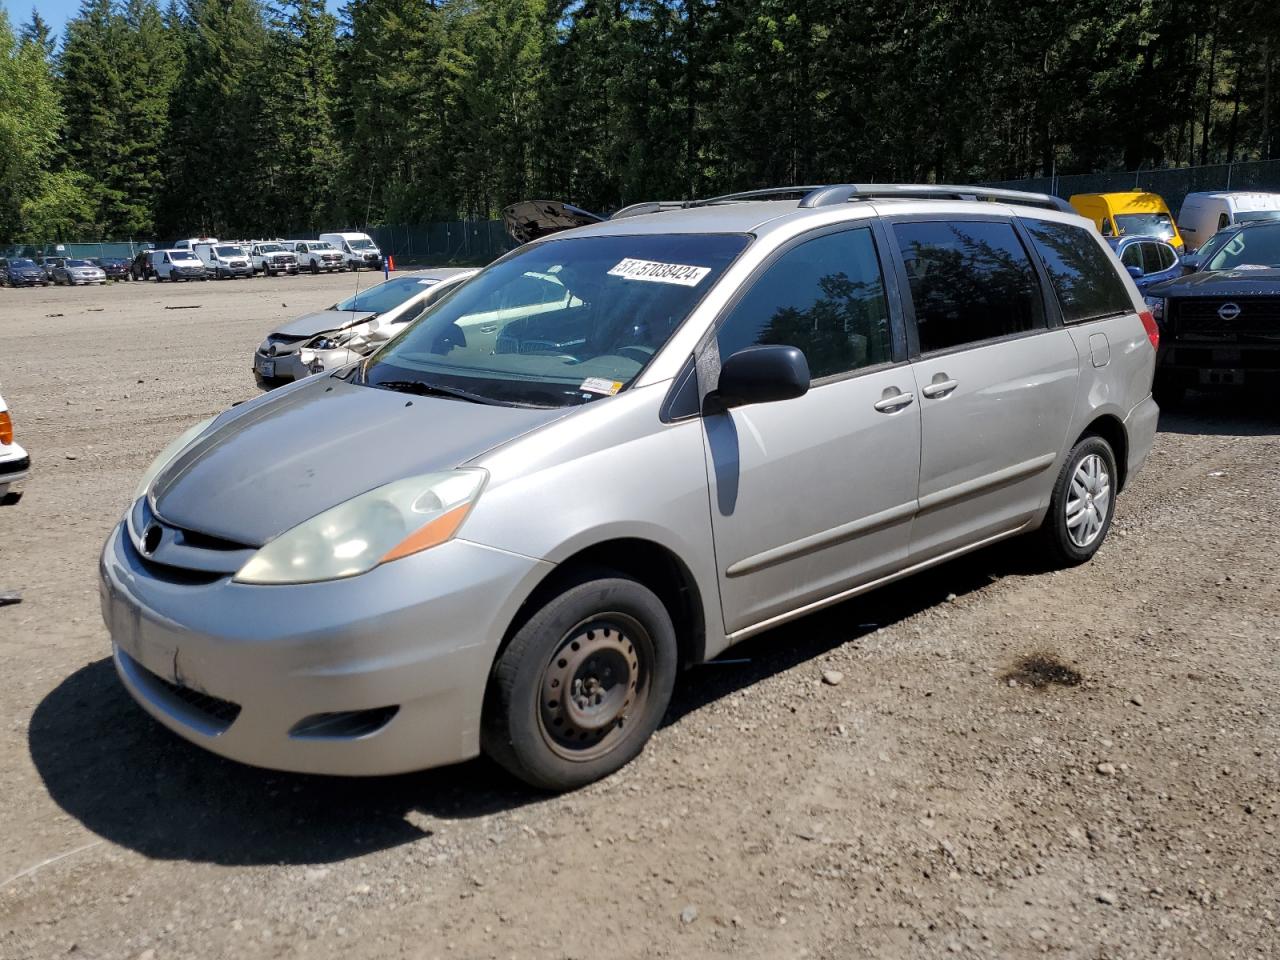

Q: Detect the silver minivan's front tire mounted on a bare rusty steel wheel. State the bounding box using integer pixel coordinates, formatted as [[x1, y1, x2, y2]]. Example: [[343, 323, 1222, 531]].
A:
[[480, 570, 677, 791]]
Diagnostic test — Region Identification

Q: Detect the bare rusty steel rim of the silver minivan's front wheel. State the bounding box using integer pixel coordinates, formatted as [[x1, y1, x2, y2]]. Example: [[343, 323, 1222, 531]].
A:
[[538, 613, 653, 762]]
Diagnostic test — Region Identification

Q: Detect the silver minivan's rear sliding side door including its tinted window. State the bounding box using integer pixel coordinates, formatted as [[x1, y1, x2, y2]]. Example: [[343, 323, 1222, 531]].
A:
[[891, 218, 1080, 561]]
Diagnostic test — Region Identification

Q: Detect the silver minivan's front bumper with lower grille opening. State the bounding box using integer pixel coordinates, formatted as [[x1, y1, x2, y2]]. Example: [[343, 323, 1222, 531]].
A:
[[100, 524, 550, 776]]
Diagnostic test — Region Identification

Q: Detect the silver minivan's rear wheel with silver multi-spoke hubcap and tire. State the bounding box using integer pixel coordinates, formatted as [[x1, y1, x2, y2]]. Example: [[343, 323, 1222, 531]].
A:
[[1038, 434, 1119, 567]]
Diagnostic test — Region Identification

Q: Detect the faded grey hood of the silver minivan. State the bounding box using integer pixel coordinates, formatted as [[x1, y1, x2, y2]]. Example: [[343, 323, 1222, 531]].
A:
[[152, 376, 572, 545]]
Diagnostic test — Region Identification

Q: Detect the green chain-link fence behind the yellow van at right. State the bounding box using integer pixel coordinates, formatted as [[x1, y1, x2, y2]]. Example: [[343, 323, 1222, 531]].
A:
[[983, 160, 1280, 212]]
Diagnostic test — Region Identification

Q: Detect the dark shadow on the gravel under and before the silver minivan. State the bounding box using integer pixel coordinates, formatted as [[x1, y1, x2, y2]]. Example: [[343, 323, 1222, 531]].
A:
[[28, 543, 1033, 865]]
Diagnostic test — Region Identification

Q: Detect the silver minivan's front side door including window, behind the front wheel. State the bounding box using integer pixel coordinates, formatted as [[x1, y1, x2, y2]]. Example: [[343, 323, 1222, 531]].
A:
[[700, 227, 920, 639]]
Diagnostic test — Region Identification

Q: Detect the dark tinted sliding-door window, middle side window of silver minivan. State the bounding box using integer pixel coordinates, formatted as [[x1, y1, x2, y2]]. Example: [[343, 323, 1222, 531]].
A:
[[893, 220, 1044, 353]]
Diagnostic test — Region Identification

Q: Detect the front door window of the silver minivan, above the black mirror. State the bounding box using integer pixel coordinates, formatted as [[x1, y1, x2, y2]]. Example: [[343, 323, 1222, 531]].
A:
[[717, 228, 892, 380]]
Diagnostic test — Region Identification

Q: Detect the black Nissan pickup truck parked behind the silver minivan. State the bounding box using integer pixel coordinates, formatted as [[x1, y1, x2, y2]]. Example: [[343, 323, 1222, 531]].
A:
[[1147, 221, 1280, 406]]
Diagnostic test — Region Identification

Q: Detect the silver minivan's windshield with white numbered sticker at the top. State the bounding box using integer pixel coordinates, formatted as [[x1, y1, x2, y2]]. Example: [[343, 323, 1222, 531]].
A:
[[357, 234, 749, 406]]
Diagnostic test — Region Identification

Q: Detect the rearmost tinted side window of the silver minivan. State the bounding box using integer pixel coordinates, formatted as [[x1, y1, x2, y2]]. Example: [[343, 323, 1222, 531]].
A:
[[1023, 220, 1133, 324]]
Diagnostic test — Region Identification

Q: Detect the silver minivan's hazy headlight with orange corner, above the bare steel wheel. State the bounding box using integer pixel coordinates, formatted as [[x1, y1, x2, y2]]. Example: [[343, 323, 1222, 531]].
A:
[[236, 468, 489, 584]]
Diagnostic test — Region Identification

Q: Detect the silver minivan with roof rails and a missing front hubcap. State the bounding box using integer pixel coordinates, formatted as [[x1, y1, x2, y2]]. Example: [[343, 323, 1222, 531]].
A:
[[101, 184, 1157, 790]]
